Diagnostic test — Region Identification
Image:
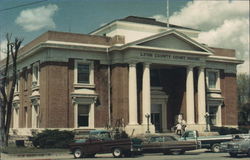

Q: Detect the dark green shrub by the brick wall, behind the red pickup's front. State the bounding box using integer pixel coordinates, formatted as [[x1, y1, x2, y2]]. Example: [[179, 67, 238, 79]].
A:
[[32, 130, 74, 148]]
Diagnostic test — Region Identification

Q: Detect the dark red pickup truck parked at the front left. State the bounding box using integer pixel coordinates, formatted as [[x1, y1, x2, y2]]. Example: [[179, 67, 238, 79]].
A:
[[69, 130, 142, 158]]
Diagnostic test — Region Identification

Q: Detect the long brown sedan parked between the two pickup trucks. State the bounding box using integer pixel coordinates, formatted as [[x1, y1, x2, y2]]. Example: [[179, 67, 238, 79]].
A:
[[142, 135, 200, 154]]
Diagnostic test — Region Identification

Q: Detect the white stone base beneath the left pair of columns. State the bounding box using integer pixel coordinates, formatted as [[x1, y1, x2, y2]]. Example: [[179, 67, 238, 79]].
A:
[[125, 124, 155, 136]]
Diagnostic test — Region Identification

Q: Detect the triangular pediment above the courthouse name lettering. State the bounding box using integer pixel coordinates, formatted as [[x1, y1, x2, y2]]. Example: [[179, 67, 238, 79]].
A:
[[129, 30, 213, 54]]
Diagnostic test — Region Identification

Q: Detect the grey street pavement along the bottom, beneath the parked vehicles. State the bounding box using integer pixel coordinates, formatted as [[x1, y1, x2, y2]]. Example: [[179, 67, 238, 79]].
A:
[[1, 149, 250, 160]]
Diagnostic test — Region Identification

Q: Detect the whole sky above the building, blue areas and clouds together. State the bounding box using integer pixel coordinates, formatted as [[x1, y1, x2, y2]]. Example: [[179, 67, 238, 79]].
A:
[[0, 0, 249, 73]]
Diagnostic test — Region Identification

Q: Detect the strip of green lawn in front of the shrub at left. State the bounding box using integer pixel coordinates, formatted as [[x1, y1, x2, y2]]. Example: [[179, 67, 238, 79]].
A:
[[3, 144, 69, 154]]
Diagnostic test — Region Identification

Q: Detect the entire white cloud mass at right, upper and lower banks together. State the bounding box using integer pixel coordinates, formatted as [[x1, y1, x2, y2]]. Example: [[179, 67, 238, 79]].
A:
[[153, 0, 249, 73]]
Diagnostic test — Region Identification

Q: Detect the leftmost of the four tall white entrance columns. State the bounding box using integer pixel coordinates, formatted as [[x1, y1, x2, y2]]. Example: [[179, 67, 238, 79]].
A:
[[129, 64, 138, 125]]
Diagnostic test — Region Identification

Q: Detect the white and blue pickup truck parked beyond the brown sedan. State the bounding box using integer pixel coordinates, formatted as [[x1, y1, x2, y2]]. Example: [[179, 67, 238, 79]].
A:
[[181, 131, 233, 152]]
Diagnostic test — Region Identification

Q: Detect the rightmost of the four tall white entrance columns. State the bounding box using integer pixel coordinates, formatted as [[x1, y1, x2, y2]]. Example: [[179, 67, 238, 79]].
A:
[[198, 67, 206, 124]]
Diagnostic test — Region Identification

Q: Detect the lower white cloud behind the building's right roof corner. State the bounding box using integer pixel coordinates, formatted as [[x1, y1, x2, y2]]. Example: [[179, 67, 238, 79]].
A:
[[198, 18, 249, 73]]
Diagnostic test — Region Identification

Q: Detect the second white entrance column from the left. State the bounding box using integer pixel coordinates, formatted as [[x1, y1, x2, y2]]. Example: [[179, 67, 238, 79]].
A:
[[142, 63, 151, 124]]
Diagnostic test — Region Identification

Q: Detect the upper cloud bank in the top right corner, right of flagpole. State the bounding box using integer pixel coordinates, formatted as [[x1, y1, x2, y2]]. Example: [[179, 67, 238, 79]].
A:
[[170, 0, 249, 30]]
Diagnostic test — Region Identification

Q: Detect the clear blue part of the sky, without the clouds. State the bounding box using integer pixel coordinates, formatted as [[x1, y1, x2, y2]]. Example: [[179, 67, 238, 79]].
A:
[[0, 0, 188, 43]]
